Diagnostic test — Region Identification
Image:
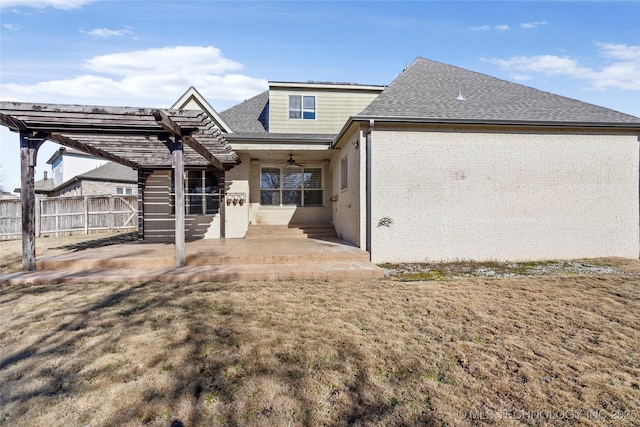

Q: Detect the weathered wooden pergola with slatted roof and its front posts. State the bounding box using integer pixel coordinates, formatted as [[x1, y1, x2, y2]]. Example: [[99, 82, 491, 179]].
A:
[[0, 102, 239, 270]]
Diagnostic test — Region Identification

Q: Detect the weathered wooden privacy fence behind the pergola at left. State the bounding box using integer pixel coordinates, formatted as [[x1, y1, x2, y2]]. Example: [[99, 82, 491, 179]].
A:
[[0, 195, 138, 240]]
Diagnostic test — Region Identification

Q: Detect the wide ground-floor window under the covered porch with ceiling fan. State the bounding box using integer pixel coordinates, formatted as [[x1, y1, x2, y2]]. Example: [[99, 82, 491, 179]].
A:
[[260, 166, 323, 206]]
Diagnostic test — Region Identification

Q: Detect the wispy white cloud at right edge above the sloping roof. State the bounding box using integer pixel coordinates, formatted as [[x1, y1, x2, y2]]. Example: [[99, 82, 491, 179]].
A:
[[482, 43, 640, 90]]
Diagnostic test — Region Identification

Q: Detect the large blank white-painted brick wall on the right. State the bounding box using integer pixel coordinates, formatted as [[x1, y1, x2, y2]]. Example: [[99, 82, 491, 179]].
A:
[[372, 131, 639, 262]]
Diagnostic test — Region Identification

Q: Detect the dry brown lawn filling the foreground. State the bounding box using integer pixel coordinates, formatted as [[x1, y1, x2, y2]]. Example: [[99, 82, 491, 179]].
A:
[[0, 236, 640, 427]]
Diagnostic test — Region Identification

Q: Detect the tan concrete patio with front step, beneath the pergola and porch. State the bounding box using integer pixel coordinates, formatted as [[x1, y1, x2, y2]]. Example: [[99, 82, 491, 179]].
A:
[[1, 238, 384, 285]]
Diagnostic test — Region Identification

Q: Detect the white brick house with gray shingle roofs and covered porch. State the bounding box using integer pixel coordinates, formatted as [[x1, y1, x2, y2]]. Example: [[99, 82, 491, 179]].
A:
[[165, 58, 640, 263]]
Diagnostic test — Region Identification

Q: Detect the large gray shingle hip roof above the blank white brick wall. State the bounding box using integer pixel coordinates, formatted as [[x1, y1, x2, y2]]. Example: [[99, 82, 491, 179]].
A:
[[359, 58, 640, 125]]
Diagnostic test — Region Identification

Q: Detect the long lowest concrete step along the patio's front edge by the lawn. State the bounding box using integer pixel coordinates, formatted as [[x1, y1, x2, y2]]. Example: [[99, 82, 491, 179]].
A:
[[2, 262, 384, 285]]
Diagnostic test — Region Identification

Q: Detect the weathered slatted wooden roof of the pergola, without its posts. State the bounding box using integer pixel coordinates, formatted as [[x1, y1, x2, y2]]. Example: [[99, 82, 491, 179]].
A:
[[0, 102, 239, 170]]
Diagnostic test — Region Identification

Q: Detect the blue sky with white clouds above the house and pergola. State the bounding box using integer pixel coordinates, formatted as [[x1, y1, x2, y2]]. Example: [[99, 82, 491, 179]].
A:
[[0, 0, 640, 191]]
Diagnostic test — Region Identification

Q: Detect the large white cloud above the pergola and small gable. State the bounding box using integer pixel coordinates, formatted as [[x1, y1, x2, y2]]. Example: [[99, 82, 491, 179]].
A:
[[0, 46, 267, 109]]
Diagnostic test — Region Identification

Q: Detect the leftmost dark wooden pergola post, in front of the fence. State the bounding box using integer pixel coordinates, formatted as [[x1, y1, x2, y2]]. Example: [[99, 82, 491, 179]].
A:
[[20, 132, 45, 271]]
